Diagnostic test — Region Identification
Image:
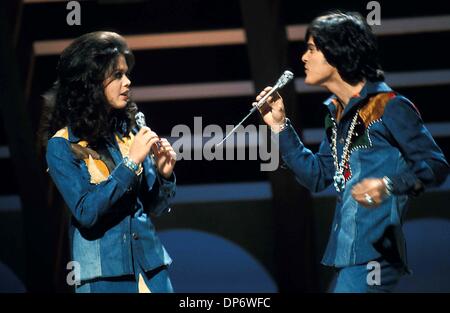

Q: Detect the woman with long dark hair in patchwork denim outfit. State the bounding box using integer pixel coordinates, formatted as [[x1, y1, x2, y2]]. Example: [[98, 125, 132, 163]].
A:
[[42, 32, 176, 292]]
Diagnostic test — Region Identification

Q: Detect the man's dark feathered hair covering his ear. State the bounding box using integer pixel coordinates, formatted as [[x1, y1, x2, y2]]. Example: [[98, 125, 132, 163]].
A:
[[305, 11, 384, 85]]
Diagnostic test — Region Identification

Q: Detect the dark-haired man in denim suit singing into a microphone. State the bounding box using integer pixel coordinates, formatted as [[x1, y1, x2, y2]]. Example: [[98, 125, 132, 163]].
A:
[[253, 12, 449, 292]]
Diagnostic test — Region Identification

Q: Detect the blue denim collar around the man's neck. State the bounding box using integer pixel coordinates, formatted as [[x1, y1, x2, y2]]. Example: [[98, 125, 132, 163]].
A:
[[323, 81, 392, 120]]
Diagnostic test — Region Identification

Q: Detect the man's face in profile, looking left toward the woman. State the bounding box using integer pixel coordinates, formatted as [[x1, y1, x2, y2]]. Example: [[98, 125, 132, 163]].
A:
[[302, 36, 338, 86]]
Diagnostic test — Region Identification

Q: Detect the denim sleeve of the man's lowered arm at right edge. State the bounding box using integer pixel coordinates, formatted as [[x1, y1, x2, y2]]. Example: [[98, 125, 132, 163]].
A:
[[382, 96, 449, 195]]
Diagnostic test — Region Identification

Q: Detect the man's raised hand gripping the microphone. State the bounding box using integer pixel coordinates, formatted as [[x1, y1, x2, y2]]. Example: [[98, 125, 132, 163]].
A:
[[252, 87, 286, 129]]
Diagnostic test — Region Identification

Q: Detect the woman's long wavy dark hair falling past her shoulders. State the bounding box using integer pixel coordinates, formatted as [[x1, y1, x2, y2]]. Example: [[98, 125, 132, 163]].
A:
[[40, 31, 137, 146]]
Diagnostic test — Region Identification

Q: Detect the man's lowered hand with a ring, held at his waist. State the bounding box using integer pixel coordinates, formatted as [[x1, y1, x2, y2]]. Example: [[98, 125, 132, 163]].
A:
[[352, 178, 387, 208]]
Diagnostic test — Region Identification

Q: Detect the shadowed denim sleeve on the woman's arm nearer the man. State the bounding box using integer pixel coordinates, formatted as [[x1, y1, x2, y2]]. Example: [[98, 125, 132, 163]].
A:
[[139, 157, 176, 216]]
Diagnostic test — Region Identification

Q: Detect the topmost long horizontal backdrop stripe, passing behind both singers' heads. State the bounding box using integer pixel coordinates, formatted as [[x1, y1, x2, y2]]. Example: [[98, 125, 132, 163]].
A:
[[33, 15, 450, 55]]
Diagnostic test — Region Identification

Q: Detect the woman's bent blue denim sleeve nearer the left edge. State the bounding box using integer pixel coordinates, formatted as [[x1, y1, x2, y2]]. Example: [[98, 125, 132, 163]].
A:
[[46, 138, 136, 228]]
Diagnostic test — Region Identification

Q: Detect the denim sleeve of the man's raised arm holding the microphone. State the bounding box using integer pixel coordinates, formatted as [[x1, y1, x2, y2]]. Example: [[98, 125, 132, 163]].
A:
[[279, 122, 334, 192]]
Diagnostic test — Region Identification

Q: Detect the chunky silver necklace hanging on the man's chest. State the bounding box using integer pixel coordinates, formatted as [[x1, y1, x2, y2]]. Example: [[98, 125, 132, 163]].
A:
[[331, 110, 359, 192]]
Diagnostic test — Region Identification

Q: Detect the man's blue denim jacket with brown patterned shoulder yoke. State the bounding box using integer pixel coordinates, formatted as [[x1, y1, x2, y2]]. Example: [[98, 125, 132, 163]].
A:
[[279, 82, 449, 271]]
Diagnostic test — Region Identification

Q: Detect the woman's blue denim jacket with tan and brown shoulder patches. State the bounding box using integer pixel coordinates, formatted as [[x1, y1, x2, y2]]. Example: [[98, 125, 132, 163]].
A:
[[46, 127, 176, 281]]
